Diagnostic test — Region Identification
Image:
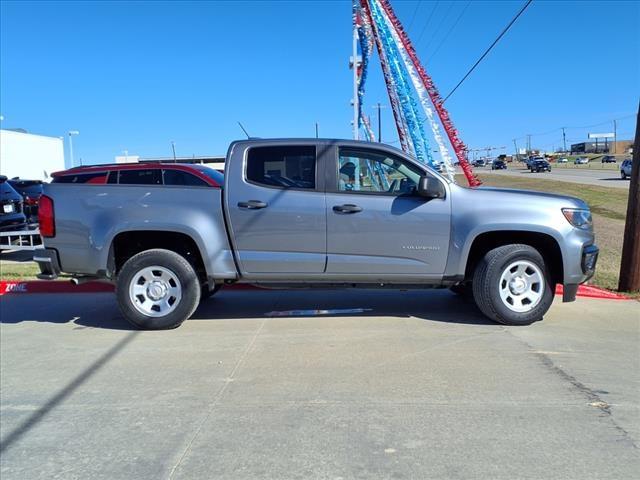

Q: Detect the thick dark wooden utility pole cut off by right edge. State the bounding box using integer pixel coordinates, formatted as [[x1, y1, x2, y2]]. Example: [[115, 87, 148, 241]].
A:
[[618, 105, 640, 292]]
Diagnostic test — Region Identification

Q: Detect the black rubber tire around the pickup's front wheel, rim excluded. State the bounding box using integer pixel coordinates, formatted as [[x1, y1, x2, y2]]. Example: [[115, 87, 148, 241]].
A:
[[472, 244, 555, 325]]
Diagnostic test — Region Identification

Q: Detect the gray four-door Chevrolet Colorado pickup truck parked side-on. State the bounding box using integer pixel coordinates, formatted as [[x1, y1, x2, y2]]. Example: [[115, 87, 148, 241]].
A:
[[35, 139, 598, 329]]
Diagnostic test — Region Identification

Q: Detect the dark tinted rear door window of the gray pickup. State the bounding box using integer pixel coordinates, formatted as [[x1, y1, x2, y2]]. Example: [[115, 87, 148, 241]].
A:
[[246, 146, 316, 189]]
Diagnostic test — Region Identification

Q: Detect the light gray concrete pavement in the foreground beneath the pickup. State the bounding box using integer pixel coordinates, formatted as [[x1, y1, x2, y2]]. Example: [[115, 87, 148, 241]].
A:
[[0, 290, 640, 480]]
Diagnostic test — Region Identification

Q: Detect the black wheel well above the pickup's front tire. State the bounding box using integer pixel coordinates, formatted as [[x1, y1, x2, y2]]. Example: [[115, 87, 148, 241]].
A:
[[464, 230, 564, 283]]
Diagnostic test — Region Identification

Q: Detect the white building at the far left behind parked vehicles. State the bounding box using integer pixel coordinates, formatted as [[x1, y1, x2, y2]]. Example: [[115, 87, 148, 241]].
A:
[[0, 130, 65, 181]]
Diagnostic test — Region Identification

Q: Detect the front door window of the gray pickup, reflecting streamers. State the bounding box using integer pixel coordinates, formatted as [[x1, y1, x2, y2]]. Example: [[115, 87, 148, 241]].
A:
[[337, 147, 424, 195]]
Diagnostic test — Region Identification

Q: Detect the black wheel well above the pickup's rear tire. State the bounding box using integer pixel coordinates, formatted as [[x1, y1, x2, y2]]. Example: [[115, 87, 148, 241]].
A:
[[109, 230, 207, 283]]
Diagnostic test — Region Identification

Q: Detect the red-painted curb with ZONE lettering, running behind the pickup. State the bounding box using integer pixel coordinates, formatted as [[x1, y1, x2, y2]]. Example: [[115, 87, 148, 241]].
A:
[[0, 280, 630, 300]]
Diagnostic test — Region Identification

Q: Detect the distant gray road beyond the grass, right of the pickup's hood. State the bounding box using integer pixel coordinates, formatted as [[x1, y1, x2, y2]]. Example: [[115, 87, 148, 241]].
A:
[[482, 166, 629, 189]]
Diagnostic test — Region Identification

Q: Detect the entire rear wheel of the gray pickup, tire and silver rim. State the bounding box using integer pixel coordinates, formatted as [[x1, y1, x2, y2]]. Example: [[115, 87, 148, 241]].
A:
[[116, 249, 200, 330]]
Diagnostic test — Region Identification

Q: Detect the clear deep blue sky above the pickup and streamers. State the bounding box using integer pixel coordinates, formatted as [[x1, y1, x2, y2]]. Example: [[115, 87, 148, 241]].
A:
[[0, 0, 640, 164]]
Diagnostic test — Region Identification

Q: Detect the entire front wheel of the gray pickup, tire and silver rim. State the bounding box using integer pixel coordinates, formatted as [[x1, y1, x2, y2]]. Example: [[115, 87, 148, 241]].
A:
[[472, 244, 554, 325]]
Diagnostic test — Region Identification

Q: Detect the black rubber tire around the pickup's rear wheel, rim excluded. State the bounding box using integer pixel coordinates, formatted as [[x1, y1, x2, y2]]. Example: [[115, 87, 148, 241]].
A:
[[116, 249, 201, 330]]
